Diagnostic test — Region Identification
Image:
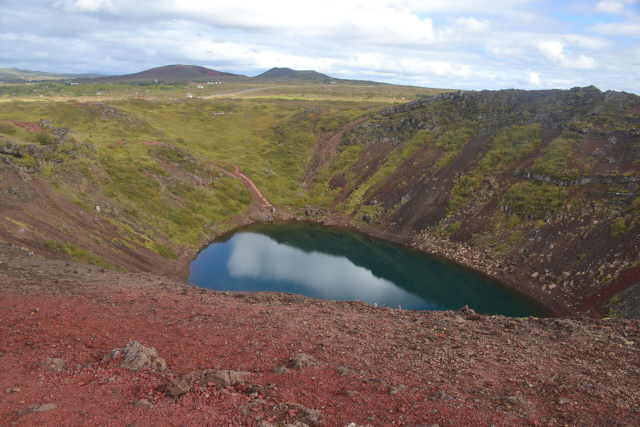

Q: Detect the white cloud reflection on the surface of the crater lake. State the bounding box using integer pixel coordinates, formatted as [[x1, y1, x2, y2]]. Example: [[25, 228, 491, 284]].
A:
[[227, 233, 413, 305]]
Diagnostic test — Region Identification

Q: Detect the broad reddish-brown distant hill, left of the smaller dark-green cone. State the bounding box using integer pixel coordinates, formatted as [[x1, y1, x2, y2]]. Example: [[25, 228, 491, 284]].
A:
[[92, 64, 248, 82]]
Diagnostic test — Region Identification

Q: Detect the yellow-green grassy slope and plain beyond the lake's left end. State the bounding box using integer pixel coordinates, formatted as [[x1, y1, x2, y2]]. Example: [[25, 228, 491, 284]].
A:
[[0, 86, 390, 270]]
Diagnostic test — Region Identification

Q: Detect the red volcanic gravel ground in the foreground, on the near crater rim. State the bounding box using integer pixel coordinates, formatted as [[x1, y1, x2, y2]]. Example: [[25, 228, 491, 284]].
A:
[[0, 245, 640, 426]]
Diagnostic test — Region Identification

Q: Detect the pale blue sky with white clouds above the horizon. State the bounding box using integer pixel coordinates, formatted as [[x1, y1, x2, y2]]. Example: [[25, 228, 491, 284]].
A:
[[0, 0, 640, 93]]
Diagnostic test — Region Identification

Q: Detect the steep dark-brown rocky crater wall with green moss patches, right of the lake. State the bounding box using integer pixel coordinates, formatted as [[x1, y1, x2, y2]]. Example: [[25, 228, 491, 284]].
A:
[[314, 87, 640, 312]]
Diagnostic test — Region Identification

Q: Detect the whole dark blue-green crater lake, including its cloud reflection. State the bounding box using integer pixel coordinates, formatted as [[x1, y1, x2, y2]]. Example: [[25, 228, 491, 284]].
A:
[[189, 222, 549, 317]]
